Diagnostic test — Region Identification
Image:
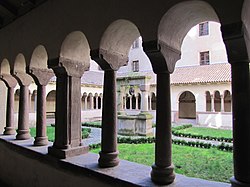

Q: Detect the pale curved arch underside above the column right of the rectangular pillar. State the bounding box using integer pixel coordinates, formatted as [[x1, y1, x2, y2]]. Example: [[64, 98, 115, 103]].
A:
[[100, 19, 140, 70]]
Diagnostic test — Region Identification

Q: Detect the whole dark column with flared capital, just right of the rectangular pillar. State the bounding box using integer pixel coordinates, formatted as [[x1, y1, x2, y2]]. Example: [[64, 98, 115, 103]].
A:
[[91, 49, 128, 167]]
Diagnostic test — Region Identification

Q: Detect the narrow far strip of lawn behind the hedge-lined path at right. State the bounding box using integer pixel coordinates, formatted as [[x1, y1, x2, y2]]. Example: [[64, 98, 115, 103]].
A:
[[177, 127, 232, 138]]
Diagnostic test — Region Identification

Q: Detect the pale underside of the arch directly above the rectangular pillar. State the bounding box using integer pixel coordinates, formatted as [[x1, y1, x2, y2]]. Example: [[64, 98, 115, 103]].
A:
[[60, 31, 90, 70]]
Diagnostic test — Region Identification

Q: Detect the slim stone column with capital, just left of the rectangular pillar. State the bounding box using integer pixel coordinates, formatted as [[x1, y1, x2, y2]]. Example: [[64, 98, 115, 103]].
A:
[[27, 67, 54, 146]]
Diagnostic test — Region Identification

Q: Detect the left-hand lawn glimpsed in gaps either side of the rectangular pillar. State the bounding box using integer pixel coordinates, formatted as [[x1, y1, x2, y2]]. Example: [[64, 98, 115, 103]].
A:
[[30, 126, 91, 142]]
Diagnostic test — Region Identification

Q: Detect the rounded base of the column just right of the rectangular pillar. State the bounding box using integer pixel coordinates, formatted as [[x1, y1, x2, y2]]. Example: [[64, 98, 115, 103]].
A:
[[98, 151, 119, 168]]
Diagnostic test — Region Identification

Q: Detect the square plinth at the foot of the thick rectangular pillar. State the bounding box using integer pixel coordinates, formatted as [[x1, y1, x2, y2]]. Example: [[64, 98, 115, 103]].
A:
[[48, 146, 89, 159]]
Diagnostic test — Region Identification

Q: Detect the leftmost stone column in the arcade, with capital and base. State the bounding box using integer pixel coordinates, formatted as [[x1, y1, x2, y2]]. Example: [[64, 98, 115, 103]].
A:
[[0, 74, 17, 135]]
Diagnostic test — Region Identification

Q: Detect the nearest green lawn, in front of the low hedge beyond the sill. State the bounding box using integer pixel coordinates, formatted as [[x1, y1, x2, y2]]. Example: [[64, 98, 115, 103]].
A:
[[92, 144, 233, 182]]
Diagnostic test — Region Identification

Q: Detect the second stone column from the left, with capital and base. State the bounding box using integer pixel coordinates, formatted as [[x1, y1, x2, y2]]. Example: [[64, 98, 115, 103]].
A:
[[13, 69, 32, 140]]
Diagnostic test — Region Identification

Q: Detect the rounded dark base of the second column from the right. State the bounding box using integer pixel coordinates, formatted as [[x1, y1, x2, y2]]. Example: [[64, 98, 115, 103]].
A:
[[151, 165, 175, 185]]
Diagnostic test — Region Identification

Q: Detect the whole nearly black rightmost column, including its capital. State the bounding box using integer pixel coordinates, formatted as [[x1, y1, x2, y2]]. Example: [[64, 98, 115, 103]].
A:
[[221, 22, 250, 187]]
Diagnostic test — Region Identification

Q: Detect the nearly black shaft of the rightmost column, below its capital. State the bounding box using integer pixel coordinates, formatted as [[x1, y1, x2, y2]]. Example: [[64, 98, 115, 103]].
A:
[[231, 62, 250, 187]]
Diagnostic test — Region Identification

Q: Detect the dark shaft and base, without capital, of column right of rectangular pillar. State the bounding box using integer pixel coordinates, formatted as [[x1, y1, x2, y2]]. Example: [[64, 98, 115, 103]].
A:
[[98, 70, 119, 167]]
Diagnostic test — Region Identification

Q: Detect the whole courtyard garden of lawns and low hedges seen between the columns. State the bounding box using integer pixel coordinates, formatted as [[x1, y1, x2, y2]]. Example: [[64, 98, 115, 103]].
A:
[[30, 122, 233, 183]]
